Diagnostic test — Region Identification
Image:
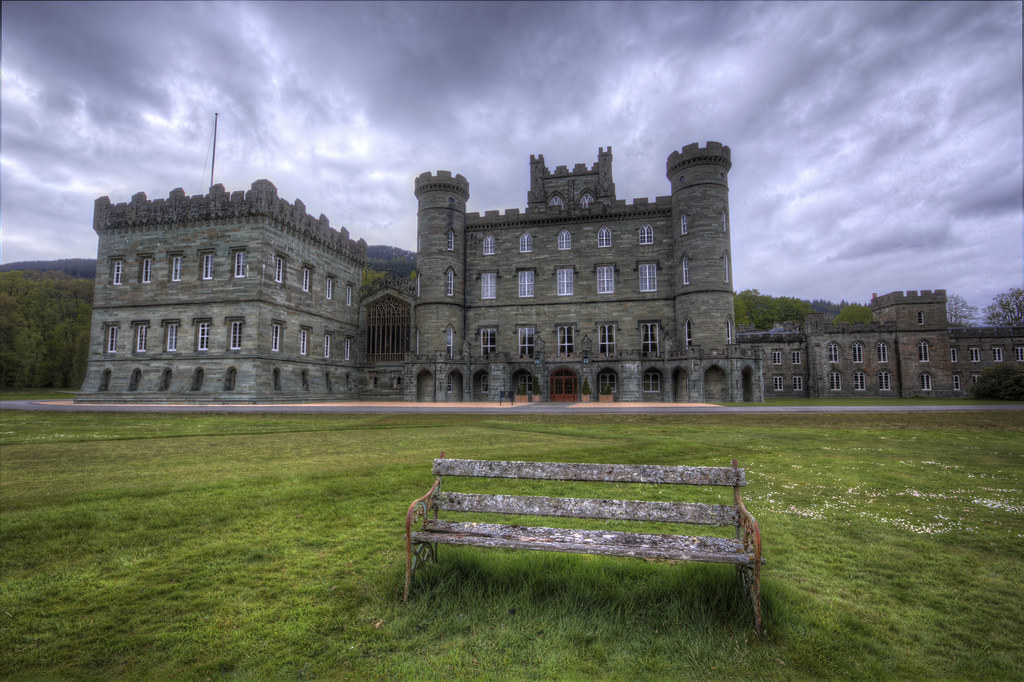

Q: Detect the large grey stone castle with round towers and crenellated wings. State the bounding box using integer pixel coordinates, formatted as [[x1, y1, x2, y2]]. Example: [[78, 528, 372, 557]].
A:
[[77, 142, 1024, 402]]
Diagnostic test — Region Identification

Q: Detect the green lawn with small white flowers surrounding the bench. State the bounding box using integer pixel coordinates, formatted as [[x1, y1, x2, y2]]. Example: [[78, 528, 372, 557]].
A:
[[0, 405, 1024, 679]]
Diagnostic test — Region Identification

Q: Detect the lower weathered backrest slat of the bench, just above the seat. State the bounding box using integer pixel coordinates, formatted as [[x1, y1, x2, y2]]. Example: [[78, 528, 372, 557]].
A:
[[435, 492, 737, 525]]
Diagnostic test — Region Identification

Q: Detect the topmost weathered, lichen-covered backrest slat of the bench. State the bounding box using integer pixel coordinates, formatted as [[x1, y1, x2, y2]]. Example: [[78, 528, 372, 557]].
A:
[[433, 459, 746, 486]]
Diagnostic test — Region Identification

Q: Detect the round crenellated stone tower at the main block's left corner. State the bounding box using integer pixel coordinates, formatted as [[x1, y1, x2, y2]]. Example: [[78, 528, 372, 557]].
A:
[[416, 171, 469, 357]]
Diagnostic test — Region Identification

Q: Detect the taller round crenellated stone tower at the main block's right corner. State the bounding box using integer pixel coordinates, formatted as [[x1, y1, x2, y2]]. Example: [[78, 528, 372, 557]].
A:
[[666, 141, 735, 350]]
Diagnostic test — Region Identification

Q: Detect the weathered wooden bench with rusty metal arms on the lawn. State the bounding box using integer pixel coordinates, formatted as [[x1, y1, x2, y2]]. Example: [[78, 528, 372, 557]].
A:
[[403, 453, 764, 635]]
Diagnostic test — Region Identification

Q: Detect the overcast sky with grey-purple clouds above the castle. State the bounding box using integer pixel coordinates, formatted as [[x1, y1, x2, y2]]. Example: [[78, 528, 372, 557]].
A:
[[0, 2, 1024, 306]]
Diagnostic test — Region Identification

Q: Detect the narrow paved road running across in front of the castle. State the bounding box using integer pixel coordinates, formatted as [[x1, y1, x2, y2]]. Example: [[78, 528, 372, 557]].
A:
[[0, 400, 1024, 415]]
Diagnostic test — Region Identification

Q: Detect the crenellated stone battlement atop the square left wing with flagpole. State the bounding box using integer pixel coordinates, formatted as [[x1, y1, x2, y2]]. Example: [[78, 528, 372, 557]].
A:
[[92, 179, 367, 263]]
